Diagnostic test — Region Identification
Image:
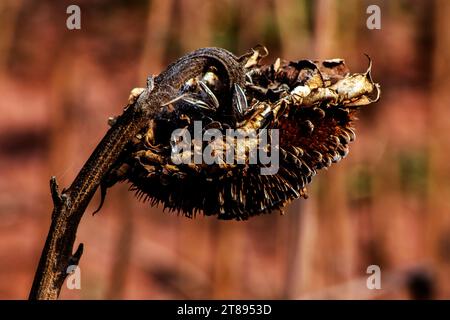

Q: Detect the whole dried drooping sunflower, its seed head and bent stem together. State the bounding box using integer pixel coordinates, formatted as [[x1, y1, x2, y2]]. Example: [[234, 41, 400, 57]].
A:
[[30, 47, 380, 299]]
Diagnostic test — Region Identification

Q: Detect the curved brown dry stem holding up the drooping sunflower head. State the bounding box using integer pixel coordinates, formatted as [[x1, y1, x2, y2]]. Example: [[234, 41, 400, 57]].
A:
[[29, 48, 244, 299]]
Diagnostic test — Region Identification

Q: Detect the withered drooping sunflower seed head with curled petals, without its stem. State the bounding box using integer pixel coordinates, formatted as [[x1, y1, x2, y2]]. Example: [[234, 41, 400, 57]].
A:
[[102, 47, 380, 220]]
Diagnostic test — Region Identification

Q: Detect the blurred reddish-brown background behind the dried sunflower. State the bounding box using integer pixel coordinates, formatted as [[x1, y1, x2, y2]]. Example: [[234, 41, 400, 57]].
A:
[[0, 0, 450, 299]]
